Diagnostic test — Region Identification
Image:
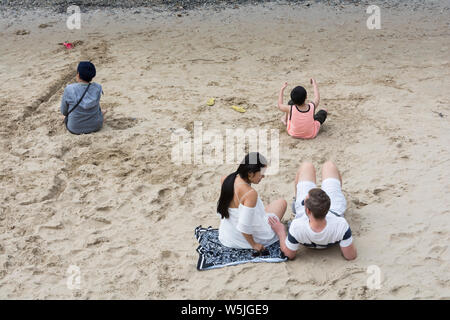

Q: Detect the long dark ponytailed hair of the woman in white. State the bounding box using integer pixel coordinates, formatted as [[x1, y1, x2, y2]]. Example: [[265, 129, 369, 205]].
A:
[[217, 152, 267, 218]]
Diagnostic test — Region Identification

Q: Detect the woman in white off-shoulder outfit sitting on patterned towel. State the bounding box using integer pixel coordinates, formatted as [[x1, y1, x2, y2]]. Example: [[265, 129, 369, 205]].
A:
[[217, 152, 287, 251]]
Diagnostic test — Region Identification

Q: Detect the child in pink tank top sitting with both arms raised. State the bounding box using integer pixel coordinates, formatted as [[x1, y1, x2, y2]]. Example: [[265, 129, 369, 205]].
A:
[[278, 79, 327, 139]]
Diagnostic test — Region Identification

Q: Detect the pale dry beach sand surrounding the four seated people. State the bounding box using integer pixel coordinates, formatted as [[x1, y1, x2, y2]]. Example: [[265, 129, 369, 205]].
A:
[[0, 2, 450, 299]]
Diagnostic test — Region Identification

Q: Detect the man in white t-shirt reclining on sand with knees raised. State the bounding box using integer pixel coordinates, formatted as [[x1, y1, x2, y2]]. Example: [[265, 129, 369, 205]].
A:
[[269, 161, 356, 260]]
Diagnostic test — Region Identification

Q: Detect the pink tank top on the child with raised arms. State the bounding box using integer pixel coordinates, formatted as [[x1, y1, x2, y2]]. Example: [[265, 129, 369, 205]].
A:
[[287, 102, 320, 139]]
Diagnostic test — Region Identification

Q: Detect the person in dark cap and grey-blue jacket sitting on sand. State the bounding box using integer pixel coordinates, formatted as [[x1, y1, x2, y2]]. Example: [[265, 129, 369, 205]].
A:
[[61, 61, 106, 134]]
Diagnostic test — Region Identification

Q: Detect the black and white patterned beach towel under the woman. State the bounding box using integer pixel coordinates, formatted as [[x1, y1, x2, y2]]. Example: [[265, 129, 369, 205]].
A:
[[195, 226, 287, 270]]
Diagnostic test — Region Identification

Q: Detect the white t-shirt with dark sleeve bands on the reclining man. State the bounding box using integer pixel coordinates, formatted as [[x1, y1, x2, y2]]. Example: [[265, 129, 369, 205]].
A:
[[286, 213, 353, 251]]
